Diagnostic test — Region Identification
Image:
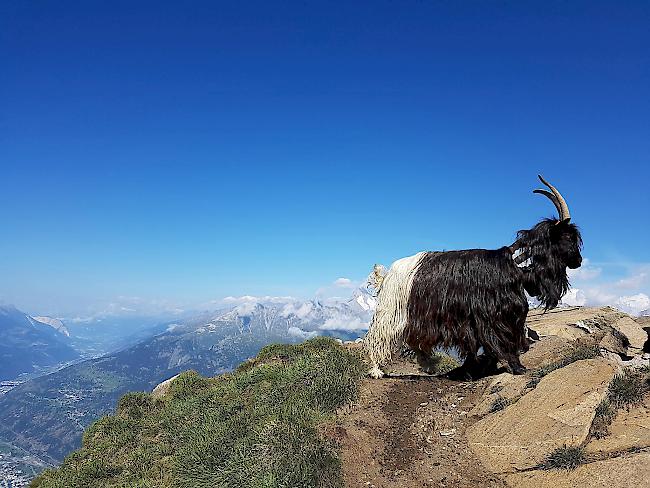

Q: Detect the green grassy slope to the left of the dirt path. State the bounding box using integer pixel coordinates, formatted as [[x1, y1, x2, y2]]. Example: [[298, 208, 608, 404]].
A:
[[32, 338, 365, 488]]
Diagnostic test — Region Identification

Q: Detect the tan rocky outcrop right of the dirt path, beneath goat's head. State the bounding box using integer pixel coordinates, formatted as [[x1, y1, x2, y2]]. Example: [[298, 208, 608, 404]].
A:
[[466, 307, 650, 488]]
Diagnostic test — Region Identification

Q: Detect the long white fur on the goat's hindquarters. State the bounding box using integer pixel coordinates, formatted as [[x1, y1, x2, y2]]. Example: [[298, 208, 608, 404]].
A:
[[364, 252, 426, 378]]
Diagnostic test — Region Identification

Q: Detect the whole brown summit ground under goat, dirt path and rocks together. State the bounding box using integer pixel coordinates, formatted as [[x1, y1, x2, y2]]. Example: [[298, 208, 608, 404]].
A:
[[336, 307, 650, 488]]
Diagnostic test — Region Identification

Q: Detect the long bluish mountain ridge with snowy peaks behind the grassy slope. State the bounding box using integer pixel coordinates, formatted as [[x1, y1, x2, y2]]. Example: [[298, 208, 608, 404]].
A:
[[0, 289, 374, 463]]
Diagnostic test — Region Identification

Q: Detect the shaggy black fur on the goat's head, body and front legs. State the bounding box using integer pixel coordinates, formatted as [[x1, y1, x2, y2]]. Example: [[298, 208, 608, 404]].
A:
[[405, 219, 582, 378]]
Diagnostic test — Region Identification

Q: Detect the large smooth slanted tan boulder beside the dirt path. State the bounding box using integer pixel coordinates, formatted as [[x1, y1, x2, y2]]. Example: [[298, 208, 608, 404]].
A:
[[467, 358, 618, 473]]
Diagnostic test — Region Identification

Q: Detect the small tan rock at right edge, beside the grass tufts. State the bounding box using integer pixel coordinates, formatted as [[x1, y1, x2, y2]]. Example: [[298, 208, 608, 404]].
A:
[[586, 405, 650, 454]]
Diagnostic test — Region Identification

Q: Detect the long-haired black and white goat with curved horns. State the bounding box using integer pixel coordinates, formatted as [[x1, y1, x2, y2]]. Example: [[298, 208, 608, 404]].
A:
[[365, 176, 582, 379]]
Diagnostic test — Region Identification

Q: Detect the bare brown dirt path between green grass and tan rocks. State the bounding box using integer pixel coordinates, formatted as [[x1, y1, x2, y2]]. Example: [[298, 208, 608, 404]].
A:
[[337, 377, 505, 488]]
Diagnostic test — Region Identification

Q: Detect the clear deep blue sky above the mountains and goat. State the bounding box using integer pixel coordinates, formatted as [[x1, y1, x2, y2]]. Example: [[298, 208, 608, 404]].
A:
[[0, 0, 650, 314]]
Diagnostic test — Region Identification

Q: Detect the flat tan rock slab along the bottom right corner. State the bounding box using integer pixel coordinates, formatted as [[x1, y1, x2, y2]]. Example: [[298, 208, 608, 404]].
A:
[[506, 452, 650, 488]]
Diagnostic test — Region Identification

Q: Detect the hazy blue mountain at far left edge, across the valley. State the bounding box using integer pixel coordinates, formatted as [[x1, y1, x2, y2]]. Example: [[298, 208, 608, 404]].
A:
[[0, 305, 79, 380]]
